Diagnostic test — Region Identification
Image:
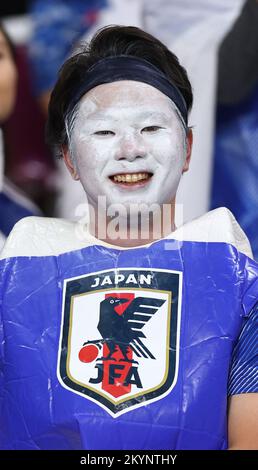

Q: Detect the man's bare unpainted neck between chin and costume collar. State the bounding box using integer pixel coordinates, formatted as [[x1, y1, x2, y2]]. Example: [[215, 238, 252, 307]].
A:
[[89, 201, 176, 248]]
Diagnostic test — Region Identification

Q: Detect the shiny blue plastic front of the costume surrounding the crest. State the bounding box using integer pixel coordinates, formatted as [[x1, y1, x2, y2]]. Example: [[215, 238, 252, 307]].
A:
[[0, 240, 258, 450]]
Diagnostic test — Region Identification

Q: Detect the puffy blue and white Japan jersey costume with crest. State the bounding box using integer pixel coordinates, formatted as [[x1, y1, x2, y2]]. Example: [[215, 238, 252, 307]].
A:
[[0, 209, 258, 450]]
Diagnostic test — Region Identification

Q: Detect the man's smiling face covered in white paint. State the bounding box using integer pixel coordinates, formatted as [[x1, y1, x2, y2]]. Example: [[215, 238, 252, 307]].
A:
[[70, 81, 186, 210]]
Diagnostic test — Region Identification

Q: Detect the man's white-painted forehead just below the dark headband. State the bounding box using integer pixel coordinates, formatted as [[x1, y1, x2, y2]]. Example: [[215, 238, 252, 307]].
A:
[[79, 80, 174, 118]]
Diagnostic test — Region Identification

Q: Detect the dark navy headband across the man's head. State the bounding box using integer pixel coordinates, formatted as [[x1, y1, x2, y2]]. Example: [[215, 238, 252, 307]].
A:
[[67, 56, 188, 126]]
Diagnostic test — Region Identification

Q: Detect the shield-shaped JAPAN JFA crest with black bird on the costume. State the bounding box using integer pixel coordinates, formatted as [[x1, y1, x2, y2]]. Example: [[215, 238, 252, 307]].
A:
[[58, 268, 182, 417]]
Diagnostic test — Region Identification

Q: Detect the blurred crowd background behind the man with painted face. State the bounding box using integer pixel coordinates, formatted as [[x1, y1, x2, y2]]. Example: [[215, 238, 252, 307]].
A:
[[0, 0, 258, 257]]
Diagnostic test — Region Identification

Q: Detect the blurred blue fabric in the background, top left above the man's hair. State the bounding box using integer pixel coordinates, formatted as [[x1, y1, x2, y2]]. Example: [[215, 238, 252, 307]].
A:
[[29, 0, 108, 94]]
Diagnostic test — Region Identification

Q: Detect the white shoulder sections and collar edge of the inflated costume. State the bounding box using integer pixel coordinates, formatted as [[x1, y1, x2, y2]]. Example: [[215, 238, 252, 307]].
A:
[[0, 207, 252, 259]]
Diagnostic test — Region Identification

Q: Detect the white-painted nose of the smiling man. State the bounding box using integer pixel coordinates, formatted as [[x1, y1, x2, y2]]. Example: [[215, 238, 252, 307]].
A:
[[115, 135, 147, 162]]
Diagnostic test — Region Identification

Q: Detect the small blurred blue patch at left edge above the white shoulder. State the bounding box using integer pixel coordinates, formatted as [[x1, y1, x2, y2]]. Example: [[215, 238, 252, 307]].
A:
[[0, 192, 33, 236]]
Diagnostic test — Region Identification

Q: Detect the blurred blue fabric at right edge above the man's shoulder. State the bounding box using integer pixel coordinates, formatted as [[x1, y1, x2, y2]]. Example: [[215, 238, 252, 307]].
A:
[[211, 88, 258, 259]]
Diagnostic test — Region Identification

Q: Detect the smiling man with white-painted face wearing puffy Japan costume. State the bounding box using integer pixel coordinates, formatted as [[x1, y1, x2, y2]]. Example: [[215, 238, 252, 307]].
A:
[[0, 26, 258, 450]]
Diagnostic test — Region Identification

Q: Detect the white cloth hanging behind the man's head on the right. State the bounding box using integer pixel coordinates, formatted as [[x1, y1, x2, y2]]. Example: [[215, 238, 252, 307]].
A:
[[145, 0, 244, 223]]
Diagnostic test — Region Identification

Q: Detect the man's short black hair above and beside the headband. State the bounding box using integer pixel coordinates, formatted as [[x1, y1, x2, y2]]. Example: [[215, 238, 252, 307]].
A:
[[46, 26, 193, 154]]
